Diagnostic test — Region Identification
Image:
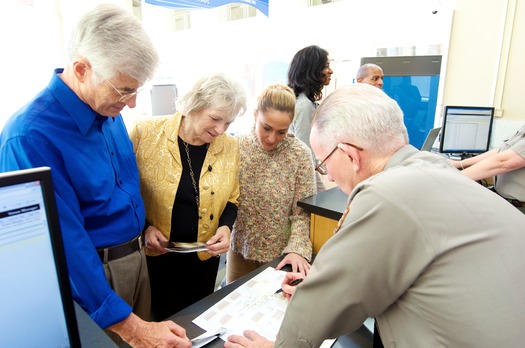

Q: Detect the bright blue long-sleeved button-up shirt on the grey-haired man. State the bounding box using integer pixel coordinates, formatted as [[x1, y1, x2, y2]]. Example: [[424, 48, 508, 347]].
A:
[[0, 69, 145, 328]]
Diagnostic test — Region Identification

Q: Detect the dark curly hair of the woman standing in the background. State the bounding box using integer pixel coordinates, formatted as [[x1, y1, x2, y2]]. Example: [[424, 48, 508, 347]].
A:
[[288, 45, 328, 102]]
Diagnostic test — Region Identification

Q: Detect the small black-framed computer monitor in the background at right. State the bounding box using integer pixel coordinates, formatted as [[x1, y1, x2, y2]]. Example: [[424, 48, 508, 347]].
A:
[[439, 105, 494, 154]]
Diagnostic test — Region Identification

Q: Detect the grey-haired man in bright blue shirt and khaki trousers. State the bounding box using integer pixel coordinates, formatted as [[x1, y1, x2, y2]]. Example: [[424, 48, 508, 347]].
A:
[[0, 5, 191, 347]]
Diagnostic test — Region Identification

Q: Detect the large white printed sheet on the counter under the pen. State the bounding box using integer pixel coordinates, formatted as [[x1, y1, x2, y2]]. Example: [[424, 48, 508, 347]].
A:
[[193, 267, 335, 347]]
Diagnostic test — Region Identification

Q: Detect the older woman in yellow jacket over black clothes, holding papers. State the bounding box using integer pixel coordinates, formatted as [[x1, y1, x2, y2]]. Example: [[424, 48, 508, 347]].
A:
[[130, 74, 246, 320]]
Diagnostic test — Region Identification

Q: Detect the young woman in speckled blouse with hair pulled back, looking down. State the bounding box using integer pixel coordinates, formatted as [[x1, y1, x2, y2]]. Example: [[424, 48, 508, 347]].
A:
[[226, 84, 316, 283]]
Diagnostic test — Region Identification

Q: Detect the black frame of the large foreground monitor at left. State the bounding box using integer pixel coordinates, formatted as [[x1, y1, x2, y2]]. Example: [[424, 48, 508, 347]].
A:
[[0, 167, 81, 348]]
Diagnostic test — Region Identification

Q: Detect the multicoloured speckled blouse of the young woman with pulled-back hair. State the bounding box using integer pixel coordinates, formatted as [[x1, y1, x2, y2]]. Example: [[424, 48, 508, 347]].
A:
[[232, 128, 316, 262]]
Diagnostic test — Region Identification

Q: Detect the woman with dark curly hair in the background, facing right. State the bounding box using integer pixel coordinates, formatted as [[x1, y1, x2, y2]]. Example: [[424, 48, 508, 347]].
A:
[[288, 45, 334, 192]]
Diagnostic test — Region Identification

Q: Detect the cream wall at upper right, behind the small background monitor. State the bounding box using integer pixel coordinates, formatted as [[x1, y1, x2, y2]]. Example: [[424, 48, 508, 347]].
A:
[[443, 0, 525, 146]]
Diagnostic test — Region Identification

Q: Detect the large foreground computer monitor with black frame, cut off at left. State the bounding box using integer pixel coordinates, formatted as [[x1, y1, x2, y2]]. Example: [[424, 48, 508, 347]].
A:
[[0, 167, 80, 347]]
